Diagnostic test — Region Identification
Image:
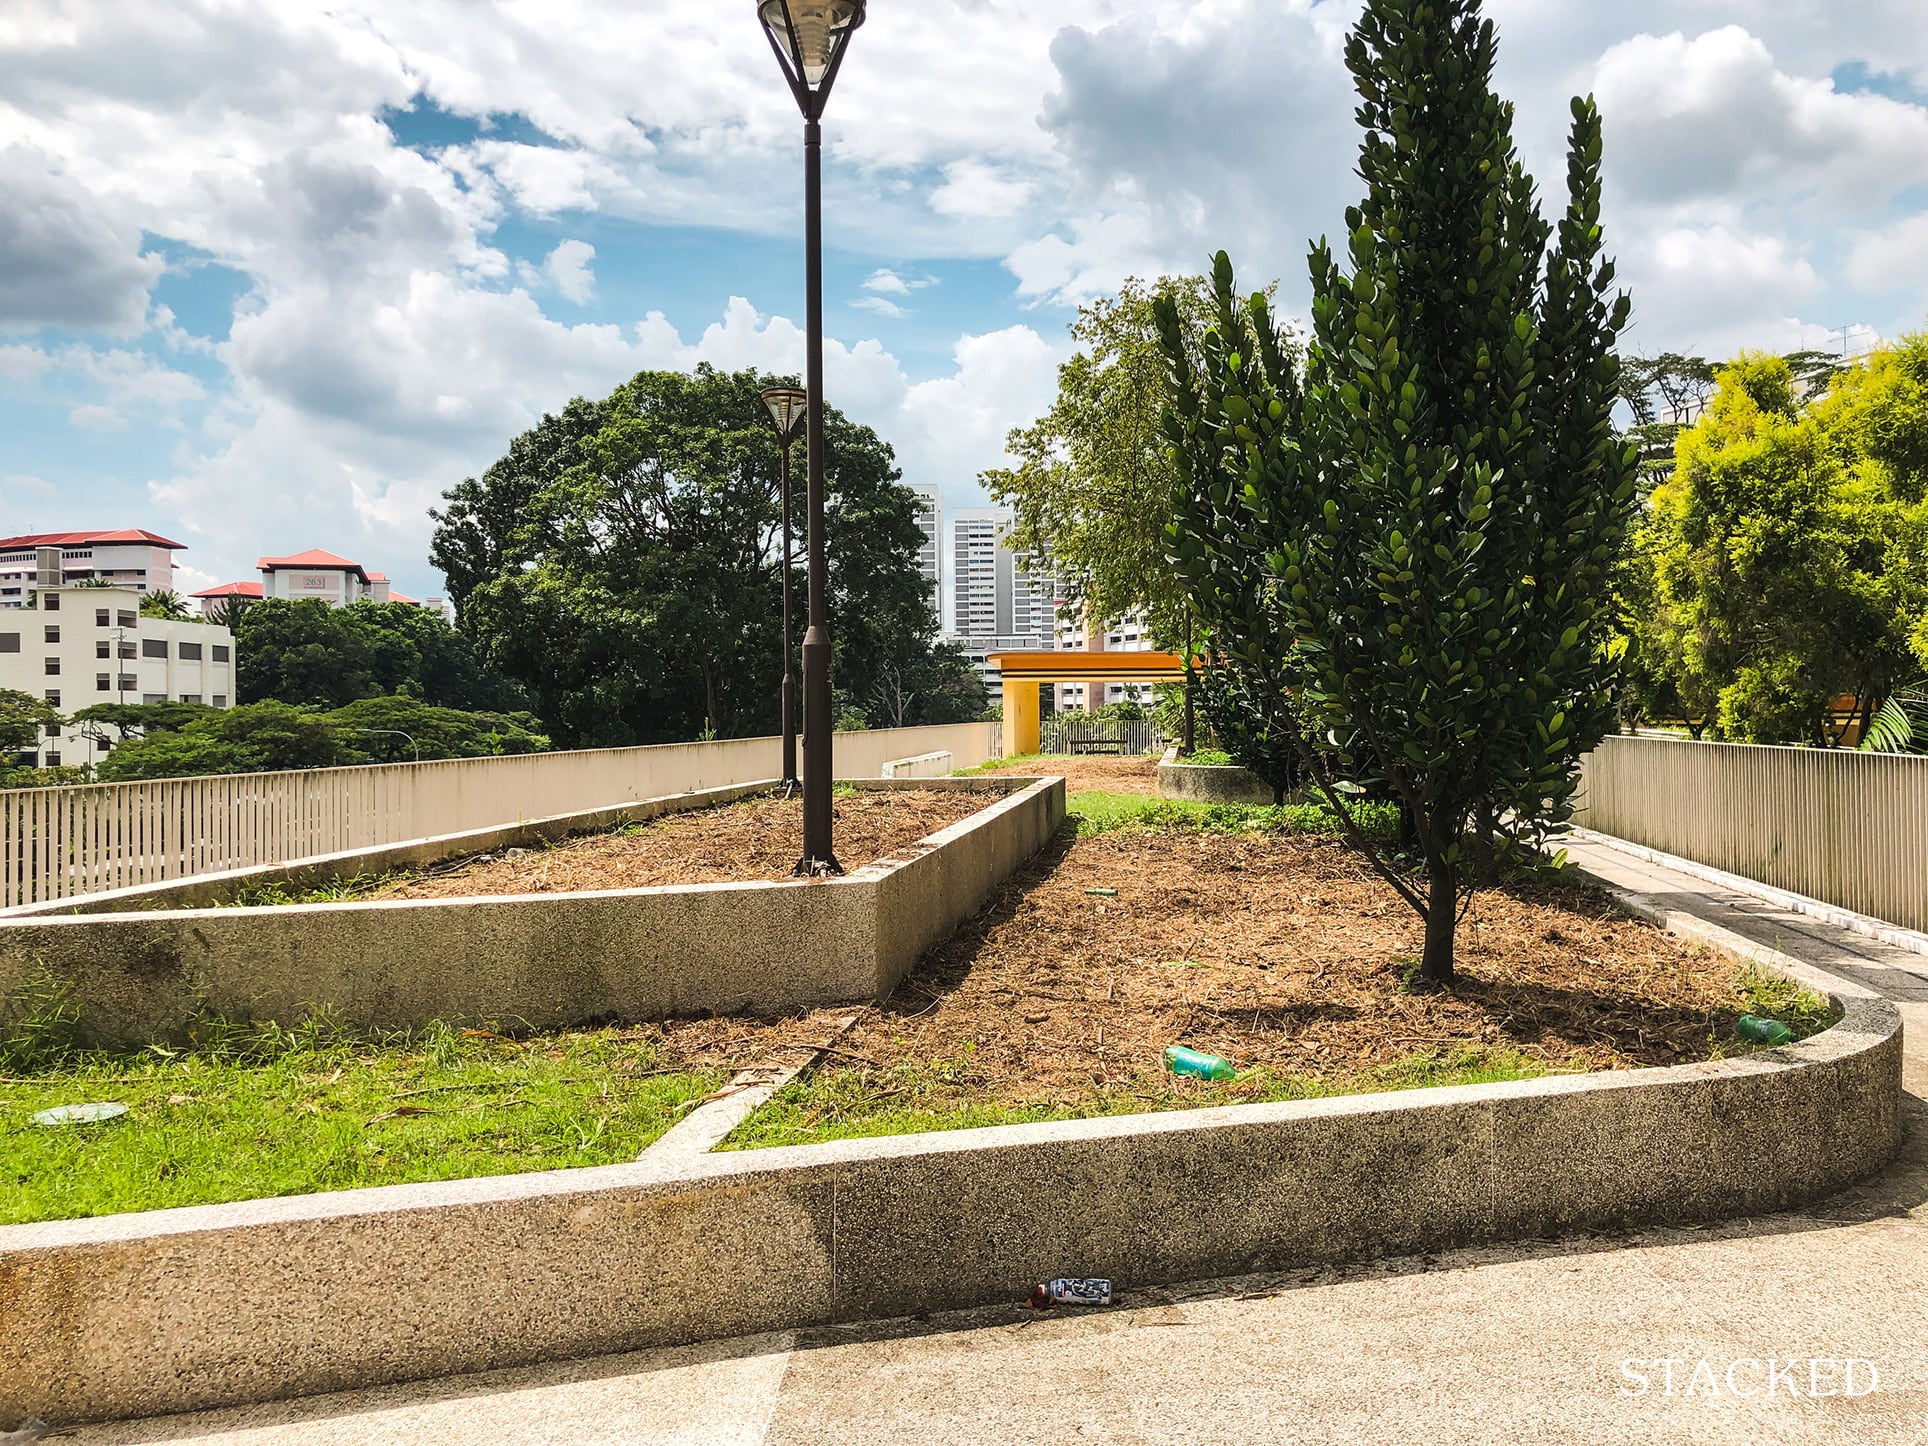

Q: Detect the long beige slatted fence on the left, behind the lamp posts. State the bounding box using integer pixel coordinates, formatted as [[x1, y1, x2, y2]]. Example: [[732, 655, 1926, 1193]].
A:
[[11, 723, 999, 908]]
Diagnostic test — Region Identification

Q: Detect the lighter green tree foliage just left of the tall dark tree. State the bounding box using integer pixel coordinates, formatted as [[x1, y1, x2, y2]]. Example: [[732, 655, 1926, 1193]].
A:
[[979, 276, 1211, 642]]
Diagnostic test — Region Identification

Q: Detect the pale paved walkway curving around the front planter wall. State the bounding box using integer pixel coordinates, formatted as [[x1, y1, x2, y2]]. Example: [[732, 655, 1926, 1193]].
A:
[[52, 844, 1928, 1446]]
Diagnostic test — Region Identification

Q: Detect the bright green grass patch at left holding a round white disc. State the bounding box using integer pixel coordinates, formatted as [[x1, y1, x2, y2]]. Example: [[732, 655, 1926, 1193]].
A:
[[0, 1001, 723, 1224]]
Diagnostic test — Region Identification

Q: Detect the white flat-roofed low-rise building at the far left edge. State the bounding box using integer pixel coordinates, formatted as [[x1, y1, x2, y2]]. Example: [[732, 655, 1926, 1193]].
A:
[[0, 586, 235, 767]]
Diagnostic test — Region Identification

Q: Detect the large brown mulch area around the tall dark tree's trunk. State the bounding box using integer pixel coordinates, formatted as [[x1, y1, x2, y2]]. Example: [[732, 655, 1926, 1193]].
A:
[[665, 831, 1739, 1109]]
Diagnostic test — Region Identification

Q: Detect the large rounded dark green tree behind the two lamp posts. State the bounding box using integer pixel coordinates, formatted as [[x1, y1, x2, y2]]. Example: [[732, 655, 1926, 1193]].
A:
[[432, 366, 956, 746]]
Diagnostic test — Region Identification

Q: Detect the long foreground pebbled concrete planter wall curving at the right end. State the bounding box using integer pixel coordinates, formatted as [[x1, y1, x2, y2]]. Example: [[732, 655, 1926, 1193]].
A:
[[0, 976, 1901, 1423]]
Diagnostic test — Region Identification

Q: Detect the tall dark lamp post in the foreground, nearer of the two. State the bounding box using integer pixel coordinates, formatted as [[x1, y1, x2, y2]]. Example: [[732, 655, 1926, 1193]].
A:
[[756, 0, 864, 877]]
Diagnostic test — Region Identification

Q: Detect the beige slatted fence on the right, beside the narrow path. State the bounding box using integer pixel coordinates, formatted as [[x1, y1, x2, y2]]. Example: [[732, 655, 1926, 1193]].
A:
[[1573, 738, 1928, 929]]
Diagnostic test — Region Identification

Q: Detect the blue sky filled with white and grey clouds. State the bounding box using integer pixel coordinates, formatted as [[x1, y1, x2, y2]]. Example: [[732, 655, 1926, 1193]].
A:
[[0, 0, 1928, 598]]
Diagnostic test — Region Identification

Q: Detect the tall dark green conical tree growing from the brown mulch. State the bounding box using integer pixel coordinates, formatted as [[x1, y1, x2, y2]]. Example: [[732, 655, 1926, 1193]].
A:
[[1159, 0, 1637, 983]]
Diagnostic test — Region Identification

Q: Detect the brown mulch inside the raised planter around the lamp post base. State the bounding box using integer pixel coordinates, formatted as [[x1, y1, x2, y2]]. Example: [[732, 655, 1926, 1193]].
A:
[[366, 789, 997, 898]]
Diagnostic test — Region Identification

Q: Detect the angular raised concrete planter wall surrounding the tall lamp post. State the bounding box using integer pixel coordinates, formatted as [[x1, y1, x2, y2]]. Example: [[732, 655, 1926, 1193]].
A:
[[0, 777, 1064, 1045]]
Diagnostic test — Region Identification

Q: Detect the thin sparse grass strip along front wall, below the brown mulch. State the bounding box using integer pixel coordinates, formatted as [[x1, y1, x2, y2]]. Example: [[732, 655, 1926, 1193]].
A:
[[719, 1049, 1548, 1149]]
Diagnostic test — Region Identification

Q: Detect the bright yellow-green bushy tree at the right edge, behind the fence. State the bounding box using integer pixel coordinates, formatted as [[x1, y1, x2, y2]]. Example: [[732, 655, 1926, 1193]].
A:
[[1621, 335, 1928, 746]]
